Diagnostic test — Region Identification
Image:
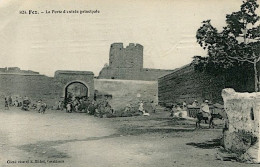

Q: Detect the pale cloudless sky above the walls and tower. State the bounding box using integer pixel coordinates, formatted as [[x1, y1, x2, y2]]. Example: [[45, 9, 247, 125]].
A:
[[0, 0, 252, 76]]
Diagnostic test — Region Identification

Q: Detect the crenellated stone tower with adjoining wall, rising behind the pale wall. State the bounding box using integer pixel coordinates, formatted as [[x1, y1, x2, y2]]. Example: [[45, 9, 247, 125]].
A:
[[98, 43, 172, 81]]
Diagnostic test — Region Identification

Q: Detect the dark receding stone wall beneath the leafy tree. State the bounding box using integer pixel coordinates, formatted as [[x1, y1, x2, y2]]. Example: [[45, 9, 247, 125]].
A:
[[158, 64, 254, 105]]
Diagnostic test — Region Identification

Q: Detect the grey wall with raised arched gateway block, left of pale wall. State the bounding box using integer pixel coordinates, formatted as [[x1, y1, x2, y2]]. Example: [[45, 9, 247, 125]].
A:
[[0, 71, 95, 106]]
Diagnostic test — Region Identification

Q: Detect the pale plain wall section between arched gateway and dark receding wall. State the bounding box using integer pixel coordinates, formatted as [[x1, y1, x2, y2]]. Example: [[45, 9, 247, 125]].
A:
[[94, 79, 158, 110]]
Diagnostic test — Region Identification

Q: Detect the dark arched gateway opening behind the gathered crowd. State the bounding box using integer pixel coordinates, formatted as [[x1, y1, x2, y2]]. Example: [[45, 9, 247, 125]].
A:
[[64, 81, 89, 104]]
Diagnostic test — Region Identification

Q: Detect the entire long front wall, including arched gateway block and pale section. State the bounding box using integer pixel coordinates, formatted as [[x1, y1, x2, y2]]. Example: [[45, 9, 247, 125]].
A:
[[0, 66, 158, 110]]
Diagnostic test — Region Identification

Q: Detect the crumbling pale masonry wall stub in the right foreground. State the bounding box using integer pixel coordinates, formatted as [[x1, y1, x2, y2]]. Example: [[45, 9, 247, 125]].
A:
[[222, 89, 260, 163]]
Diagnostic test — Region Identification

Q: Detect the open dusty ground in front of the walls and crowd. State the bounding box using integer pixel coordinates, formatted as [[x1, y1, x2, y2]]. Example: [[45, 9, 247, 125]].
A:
[[0, 108, 258, 167]]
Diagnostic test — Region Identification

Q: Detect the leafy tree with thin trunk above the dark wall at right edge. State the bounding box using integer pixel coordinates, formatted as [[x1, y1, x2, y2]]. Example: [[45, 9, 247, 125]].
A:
[[196, 0, 260, 92]]
